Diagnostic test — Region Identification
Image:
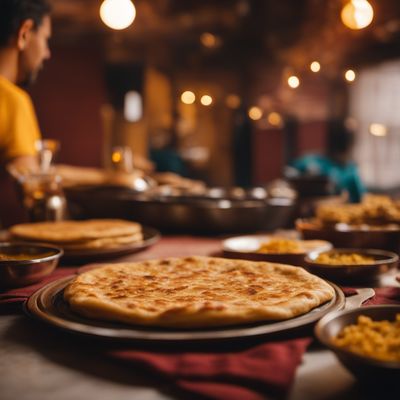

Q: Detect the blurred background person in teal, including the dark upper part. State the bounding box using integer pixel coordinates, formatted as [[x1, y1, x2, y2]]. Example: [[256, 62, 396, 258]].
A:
[[290, 120, 365, 203]]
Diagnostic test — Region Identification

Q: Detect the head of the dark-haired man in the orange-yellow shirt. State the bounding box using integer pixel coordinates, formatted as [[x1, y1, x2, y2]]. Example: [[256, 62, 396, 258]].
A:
[[0, 0, 51, 85]]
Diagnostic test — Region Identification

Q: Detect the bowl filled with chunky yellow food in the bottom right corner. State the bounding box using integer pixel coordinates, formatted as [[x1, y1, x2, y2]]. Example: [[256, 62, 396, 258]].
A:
[[315, 305, 400, 383]]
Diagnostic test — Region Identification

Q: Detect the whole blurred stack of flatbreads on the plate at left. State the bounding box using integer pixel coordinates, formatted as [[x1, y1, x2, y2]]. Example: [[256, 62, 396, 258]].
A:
[[9, 219, 143, 251]]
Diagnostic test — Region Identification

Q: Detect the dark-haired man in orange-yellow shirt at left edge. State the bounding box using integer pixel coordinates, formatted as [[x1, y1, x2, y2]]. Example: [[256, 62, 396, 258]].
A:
[[0, 0, 51, 226]]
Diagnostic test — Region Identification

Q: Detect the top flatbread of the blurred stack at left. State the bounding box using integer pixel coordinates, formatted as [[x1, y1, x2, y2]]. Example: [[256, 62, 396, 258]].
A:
[[9, 219, 141, 244]]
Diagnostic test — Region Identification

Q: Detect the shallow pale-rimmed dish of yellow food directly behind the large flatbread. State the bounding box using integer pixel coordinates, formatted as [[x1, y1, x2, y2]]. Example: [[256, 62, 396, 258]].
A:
[[222, 235, 332, 266]]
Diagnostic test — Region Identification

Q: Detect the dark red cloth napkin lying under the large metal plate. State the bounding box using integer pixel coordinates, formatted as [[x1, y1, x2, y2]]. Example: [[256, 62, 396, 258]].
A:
[[0, 268, 400, 400]]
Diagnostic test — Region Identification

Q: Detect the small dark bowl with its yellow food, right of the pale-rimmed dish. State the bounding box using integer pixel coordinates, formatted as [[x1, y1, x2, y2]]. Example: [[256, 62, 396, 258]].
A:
[[304, 249, 399, 284]]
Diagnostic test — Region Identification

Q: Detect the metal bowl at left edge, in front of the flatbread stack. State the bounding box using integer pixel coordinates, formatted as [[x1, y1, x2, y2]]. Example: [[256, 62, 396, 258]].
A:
[[0, 242, 63, 288]]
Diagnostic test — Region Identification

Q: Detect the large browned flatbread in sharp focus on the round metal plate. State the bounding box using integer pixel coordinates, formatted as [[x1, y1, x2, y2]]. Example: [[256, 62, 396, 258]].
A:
[[64, 257, 334, 328]]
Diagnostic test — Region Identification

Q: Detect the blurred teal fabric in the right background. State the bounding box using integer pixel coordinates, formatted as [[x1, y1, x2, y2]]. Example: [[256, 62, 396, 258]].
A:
[[290, 154, 365, 203]]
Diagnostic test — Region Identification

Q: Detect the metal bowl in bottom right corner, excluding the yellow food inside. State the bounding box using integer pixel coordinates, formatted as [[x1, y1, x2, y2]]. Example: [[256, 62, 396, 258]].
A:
[[315, 305, 400, 383]]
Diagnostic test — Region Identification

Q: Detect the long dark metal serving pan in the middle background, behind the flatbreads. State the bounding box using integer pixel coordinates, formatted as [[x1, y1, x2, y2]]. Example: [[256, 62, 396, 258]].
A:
[[66, 187, 295, 234]]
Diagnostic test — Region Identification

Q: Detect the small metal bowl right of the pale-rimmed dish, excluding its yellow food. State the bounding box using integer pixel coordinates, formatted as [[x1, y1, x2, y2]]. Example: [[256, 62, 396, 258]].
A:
[[304, 249, 399, 284]]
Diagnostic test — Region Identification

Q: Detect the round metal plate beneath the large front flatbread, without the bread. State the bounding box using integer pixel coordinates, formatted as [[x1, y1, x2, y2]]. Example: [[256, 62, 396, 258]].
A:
[[25, 276, 345, 343]]
